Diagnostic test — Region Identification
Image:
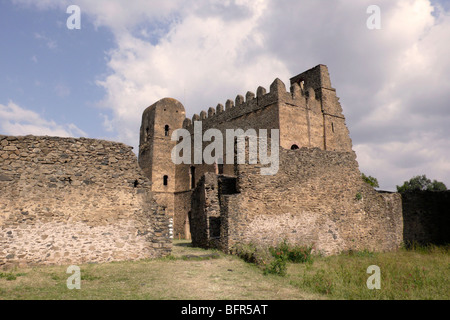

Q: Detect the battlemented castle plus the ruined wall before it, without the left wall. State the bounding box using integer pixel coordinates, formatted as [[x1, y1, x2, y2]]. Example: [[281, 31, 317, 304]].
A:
[[139, 65, 403, 254]]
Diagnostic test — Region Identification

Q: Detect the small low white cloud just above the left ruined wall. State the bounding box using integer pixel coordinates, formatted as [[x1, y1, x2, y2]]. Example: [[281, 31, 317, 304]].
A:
[[0, 101, 87, 137]]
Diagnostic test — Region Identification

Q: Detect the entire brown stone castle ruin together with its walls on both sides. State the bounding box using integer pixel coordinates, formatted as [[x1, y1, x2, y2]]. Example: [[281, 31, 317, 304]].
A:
[[0, 65, 450, 267]]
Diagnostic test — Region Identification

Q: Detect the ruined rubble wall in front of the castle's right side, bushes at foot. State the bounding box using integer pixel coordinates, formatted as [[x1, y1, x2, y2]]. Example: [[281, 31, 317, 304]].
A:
[[193, 148, 403, 254]]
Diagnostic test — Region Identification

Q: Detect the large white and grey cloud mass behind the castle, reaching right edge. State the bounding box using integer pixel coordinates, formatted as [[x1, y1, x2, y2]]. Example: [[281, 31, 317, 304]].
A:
[[7, 0, 450, 189]]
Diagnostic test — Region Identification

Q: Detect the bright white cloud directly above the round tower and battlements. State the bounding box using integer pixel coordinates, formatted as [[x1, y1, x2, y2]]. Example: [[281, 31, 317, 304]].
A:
[[95, 1, 289, 145]]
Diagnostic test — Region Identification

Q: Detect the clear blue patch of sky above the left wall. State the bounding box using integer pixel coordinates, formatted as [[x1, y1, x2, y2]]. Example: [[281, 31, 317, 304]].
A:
[[0, 1, 115, 137]]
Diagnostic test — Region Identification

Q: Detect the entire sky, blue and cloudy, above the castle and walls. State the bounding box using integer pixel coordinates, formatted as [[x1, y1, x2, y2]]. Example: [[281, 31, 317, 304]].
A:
[[0, 0, 450, 191]]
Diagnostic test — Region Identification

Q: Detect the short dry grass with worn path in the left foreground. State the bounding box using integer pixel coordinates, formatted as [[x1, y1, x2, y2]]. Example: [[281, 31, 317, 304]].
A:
[[0, 241, 320, 300]]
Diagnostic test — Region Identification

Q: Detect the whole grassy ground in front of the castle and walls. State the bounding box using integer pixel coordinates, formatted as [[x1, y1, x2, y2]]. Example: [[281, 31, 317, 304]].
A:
[[0, 241, 450, 300]]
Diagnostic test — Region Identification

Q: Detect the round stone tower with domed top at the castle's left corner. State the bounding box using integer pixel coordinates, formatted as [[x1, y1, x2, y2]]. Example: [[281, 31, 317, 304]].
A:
[[139, 98, 186, 224]]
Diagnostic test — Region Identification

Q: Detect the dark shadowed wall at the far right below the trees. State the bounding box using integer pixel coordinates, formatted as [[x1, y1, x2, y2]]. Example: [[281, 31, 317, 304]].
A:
[[401, 191, 450, 245]]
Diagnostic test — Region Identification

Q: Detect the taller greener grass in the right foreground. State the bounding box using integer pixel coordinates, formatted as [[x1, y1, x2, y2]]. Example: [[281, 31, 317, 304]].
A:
[[288, 246, 450, 300]]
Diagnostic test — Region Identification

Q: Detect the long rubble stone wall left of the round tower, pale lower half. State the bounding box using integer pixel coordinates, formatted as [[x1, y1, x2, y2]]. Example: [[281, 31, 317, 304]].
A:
[[0, 136, 171, 265]]
